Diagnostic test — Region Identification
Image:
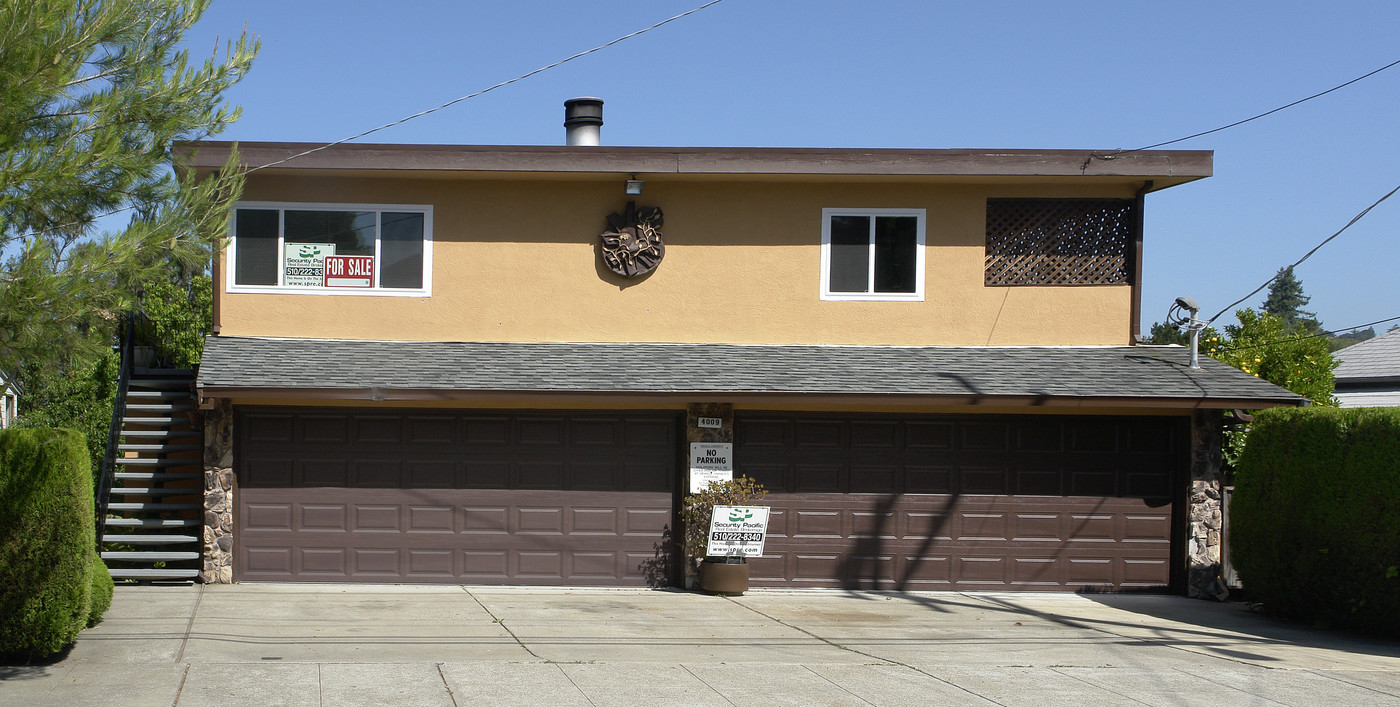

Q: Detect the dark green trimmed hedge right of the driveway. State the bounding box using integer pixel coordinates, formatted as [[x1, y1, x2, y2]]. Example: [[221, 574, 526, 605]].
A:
[[1231, 407, 1400, 636]]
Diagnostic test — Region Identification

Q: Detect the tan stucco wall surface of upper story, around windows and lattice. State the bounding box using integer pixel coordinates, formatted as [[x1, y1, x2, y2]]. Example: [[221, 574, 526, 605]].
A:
[[220, 175, 1133, 346]]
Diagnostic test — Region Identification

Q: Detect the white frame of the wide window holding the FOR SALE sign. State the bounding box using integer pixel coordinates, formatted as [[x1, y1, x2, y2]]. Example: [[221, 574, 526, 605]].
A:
[[224, 202, 433, 297]]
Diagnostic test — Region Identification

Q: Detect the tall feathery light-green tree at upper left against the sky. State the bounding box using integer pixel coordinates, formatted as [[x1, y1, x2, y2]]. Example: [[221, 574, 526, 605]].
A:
[[0, 0, 258, 386]]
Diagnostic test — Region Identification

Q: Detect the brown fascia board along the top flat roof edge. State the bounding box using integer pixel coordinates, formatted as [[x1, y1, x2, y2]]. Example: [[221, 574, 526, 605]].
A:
[[175, 141, 1214, 189]]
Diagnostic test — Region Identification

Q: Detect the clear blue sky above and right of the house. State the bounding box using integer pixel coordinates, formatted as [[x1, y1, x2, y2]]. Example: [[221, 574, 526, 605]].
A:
[[186, 0, 1400, 332]]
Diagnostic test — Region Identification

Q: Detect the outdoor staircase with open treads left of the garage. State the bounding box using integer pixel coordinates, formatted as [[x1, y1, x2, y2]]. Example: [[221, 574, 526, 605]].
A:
[[101, 368, 204, 581]]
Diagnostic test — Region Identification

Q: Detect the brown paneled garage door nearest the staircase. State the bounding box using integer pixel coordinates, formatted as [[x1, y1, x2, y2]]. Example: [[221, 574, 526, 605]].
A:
[[234, 407, 676, 585]]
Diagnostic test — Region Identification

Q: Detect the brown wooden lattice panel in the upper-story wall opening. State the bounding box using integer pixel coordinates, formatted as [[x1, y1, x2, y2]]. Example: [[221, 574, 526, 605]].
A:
[[986, 199, 1137, 286]]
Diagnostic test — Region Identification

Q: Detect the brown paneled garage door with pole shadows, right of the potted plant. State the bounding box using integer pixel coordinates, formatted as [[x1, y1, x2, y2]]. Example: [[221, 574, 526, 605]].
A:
[[734, 413, 1189, 589]]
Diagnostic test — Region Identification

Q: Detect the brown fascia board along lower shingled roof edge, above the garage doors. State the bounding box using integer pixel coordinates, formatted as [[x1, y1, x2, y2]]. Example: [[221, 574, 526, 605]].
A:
[[199, 385, 1308, 410]]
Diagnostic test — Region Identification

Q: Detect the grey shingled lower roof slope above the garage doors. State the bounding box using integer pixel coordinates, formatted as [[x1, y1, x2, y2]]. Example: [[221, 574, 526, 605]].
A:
[[199, 336, 1306, 407]]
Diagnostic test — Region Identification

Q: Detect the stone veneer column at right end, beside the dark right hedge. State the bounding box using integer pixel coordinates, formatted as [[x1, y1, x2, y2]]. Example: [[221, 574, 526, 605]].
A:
[[1186, 410, 1229, 599]]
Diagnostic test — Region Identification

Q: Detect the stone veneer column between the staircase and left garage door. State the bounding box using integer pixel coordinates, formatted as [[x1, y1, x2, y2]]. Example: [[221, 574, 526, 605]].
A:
[[199, 400, 235, 584]]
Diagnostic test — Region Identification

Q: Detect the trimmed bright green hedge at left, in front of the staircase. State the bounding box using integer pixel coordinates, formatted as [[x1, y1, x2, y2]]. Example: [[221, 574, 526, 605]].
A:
[[0, 430, 95, 658]]
